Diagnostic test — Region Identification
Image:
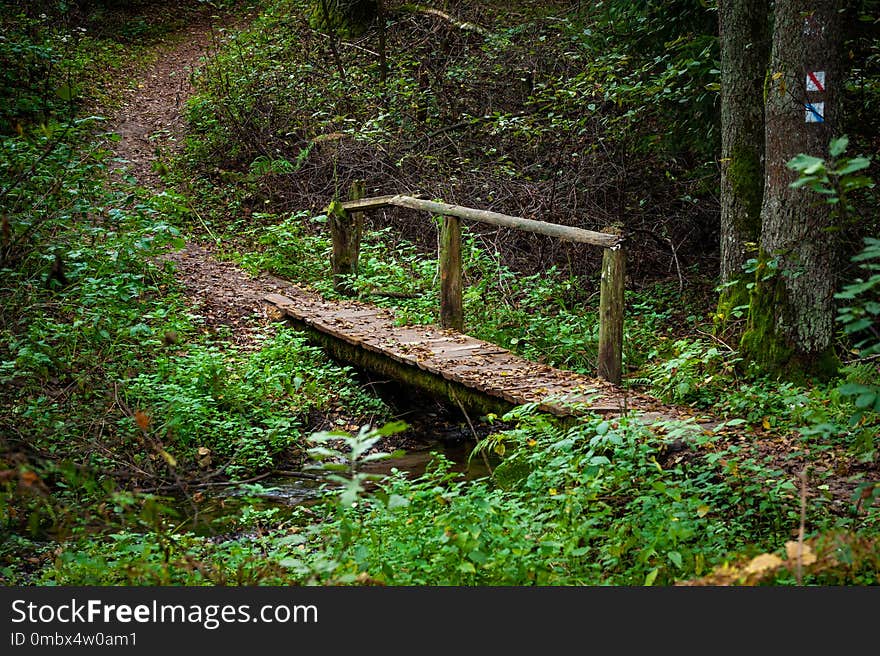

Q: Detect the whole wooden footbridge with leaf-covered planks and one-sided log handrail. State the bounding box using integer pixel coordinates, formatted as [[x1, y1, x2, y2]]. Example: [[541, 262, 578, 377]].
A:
[[265, 188, 668, 426]]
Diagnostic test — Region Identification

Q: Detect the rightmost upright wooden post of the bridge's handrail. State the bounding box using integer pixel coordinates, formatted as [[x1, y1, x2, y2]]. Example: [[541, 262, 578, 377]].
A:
[[598, 244, 626, 385]]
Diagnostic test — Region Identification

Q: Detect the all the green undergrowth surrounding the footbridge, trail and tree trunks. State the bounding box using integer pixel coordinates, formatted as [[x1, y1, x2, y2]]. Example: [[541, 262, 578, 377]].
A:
[[0, 2, 880, 586]]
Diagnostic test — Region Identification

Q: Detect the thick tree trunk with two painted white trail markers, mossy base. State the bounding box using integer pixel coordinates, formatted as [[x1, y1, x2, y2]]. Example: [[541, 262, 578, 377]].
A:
[[742, 0, 843, 377]]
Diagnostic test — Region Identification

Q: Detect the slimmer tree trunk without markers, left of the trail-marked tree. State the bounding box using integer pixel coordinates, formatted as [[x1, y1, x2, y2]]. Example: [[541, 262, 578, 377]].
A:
[[718, 0, 770, 326]]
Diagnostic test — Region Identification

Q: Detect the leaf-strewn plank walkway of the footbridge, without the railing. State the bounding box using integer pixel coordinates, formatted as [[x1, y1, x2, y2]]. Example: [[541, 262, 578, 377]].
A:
[[265, 288, 656, 417]]
